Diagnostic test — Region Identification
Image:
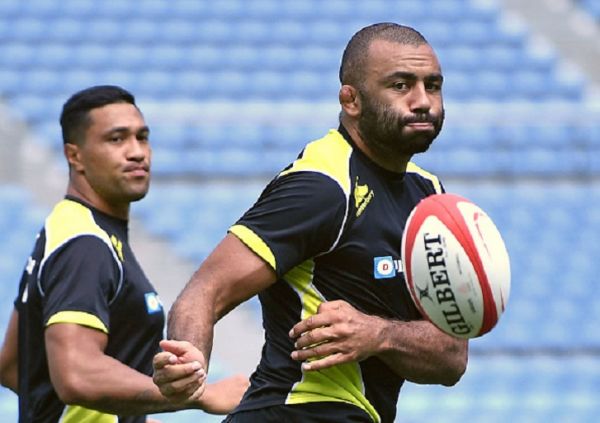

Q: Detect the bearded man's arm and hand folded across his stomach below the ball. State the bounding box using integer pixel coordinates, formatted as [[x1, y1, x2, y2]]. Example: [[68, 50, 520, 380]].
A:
[[290, 301, 468, 386]]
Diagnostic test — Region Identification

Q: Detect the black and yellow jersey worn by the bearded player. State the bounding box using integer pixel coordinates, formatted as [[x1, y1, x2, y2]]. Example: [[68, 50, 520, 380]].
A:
[[229, 127, 443, 422]]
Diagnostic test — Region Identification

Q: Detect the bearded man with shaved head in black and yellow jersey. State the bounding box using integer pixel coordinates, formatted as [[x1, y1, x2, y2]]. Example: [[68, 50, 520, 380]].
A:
[[154, 23, 468, 423]]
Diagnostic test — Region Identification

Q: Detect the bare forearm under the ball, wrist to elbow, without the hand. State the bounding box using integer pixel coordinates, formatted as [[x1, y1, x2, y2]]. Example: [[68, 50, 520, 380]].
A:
[[374, 317, 468, 386]]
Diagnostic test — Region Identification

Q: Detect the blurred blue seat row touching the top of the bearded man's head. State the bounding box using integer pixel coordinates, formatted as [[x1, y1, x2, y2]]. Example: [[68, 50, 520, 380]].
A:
[[0, 16, 522, 46]]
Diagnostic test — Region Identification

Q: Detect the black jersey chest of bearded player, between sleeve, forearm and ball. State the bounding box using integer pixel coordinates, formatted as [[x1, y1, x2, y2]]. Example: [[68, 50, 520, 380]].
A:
[[314, 174, 429, 319]]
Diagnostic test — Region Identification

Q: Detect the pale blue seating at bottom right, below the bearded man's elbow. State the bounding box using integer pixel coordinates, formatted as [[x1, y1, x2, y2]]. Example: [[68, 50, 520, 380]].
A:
[[397, 354, 600, 423]]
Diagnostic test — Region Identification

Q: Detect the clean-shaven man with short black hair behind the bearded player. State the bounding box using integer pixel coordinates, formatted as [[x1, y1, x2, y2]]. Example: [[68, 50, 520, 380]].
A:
[[0, 86, 247, 423]]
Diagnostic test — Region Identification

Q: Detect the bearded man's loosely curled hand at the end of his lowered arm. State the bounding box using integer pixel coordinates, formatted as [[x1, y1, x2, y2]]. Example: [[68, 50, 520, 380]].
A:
[[152, 340, 206, 406]]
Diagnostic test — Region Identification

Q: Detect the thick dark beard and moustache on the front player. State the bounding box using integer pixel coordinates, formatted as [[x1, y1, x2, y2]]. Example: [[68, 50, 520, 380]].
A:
[[358, 95, 444, 157]]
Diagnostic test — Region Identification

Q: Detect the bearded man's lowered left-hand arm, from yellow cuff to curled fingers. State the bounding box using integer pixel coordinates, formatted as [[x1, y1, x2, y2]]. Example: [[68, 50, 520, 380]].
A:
[[154, 234, 276, 401]]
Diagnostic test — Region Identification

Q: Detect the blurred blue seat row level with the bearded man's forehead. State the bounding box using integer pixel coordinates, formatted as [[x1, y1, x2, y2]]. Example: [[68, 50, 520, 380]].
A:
[[0, 42, 557, 74]]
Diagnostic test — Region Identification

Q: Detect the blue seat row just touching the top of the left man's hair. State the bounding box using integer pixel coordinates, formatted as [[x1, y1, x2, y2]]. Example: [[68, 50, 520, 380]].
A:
[[0, 69, 584, 102]]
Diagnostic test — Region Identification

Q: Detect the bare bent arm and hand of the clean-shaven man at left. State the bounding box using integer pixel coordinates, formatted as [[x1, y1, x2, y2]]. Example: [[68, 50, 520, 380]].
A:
[[45, 323, 247, 414]]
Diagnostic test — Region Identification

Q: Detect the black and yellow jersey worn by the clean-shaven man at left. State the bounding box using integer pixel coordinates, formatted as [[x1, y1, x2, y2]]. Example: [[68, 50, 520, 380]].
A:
[[15, 197, 164, 423]]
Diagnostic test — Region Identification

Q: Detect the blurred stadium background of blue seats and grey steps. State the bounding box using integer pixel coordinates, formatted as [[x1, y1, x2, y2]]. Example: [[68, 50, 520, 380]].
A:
[[0, 0, 600, 423]]
